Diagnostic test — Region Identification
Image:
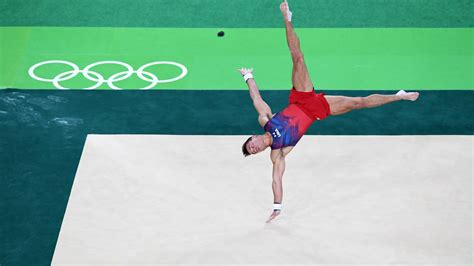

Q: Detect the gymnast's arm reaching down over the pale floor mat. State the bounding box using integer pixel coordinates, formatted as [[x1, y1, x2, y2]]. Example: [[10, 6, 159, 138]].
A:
[[267, 150, 285, 223]]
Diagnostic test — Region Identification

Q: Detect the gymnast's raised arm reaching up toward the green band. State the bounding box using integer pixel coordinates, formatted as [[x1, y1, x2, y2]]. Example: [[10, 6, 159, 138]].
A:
[[239, 68, 272, 126]]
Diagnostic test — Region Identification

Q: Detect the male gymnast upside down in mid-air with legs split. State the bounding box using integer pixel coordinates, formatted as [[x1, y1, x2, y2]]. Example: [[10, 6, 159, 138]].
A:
[[239, 0, 419, 223]]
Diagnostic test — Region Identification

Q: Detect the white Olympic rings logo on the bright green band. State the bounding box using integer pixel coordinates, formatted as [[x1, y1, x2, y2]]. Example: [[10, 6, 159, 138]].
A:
[[28, 60, 188, 90]]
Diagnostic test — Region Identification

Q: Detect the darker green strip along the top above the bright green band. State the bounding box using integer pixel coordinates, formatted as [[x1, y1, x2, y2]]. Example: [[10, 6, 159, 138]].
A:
[[0, 0, 474, 28]]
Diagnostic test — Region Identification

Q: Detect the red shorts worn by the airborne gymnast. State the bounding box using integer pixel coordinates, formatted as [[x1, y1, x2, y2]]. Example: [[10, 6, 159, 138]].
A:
[[288, 87, 331, 120]]
